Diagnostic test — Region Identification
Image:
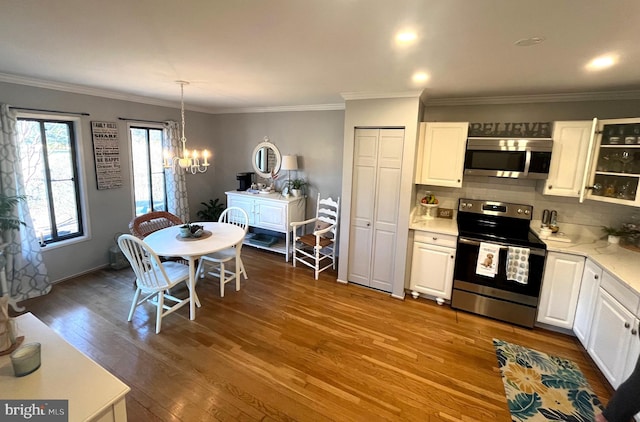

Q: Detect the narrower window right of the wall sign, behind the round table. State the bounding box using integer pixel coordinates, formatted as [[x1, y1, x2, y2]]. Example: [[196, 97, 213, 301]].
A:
[[129, 126, 167, 216]]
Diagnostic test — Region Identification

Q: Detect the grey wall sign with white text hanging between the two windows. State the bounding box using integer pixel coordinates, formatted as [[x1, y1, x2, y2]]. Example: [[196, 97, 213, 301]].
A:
[[91, 122, 122, 189]]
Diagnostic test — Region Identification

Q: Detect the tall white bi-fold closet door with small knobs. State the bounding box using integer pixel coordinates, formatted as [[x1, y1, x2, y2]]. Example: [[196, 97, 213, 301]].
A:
[[348, 129, 404, 292]]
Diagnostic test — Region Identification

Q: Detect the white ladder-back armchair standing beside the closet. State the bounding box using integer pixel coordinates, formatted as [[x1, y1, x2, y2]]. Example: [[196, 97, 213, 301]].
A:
[[291, 193, 340, 280]]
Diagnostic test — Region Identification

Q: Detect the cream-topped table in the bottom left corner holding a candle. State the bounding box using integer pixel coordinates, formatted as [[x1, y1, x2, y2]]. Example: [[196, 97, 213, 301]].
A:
[[0, 313, 130, 422]]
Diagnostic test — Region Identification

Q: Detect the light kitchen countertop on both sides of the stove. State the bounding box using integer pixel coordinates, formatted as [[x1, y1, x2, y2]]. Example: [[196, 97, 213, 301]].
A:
[[409, 209, 640, 294]]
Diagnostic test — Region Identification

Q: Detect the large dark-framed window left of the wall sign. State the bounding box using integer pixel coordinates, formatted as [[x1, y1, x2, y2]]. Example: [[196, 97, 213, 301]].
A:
[[17, 116, 84, 244]]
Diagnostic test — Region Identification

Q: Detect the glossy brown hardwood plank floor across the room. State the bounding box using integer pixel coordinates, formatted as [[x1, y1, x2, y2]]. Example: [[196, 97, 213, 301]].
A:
[[17, 247, 611, 421]]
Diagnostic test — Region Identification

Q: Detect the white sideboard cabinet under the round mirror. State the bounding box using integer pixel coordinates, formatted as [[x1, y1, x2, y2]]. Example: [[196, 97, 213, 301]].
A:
[[225, 191, 306, 261]]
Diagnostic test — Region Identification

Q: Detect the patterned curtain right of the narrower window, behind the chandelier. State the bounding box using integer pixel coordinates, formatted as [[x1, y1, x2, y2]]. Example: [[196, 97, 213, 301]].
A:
[[163, 121, 190, 222]]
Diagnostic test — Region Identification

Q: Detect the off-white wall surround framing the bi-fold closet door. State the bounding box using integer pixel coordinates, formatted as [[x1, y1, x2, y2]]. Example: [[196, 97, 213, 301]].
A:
[[338, 97, 421, 298]]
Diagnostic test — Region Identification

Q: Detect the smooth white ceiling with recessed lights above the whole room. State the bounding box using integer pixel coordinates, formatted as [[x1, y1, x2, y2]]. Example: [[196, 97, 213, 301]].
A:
[[0, 0, 640, 112]]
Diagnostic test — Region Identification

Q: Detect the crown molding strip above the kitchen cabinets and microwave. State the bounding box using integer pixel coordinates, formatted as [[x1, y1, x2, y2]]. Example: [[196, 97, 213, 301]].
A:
[[424, 90, 640, 107]]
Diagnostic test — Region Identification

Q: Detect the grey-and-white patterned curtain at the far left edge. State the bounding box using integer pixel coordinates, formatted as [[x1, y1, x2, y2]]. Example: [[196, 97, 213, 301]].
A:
[[0, 104, 51, 310]]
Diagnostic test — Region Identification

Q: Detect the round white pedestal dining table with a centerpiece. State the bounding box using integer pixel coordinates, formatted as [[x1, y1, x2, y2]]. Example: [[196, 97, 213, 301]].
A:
[[144, 222, 245, 320]]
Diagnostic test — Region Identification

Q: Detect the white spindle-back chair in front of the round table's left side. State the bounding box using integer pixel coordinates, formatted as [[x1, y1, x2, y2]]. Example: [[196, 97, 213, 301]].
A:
[[118, 234, 200, 334]]
